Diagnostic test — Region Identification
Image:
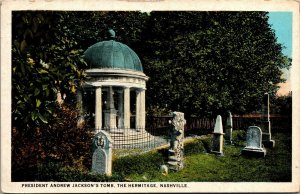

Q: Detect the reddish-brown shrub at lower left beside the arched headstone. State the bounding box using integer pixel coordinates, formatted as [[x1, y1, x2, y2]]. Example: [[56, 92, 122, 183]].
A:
[[12, 106, 92, 181]]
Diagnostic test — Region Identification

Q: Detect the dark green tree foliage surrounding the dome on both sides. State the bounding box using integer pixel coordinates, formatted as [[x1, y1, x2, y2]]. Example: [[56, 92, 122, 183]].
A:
[[12, 11, 291, 125]]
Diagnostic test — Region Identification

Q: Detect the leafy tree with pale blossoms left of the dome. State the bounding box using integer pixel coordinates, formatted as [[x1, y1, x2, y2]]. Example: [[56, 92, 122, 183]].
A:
[[12, 11, 85, 129]]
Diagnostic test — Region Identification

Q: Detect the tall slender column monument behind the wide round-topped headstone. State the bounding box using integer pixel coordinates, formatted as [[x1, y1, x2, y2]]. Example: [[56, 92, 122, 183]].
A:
[[260, 93, 275, 148]]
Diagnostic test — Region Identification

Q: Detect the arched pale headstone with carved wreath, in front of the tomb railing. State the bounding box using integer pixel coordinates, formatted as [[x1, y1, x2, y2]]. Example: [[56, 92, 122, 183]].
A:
[[92, 130, 113, 176]]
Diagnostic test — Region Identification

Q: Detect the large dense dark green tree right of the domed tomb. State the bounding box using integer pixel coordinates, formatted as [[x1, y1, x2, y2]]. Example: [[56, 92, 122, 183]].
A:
[[141, 12, 290, 116]]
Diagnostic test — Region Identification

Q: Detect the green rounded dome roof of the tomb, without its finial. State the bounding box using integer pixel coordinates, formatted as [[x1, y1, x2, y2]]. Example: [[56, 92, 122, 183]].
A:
[[84, 40, 143, 72]]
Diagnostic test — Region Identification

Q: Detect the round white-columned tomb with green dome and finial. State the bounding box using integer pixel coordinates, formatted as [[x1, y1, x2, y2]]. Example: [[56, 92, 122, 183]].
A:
[[77, 30, 148, 146]]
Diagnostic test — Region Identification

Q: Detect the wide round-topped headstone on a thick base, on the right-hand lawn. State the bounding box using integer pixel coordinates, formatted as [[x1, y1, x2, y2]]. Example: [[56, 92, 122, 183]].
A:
[[242, 126, 266, 157]]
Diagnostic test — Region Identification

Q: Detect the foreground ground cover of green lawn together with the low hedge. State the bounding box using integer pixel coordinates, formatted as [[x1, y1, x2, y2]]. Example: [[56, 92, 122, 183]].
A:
[[27, 131, 292, 182]]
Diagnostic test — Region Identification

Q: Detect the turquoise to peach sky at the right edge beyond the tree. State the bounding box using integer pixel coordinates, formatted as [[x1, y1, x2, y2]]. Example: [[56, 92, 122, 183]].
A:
[[269, 12, 293, 95]]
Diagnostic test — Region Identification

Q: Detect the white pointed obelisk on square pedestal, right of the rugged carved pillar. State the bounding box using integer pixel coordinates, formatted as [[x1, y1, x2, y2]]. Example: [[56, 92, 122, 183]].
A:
[[211, 115, 224, 156]]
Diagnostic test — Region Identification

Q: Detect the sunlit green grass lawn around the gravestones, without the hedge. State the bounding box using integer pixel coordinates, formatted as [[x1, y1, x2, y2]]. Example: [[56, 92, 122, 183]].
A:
[[115, 133, 292, 182]]
